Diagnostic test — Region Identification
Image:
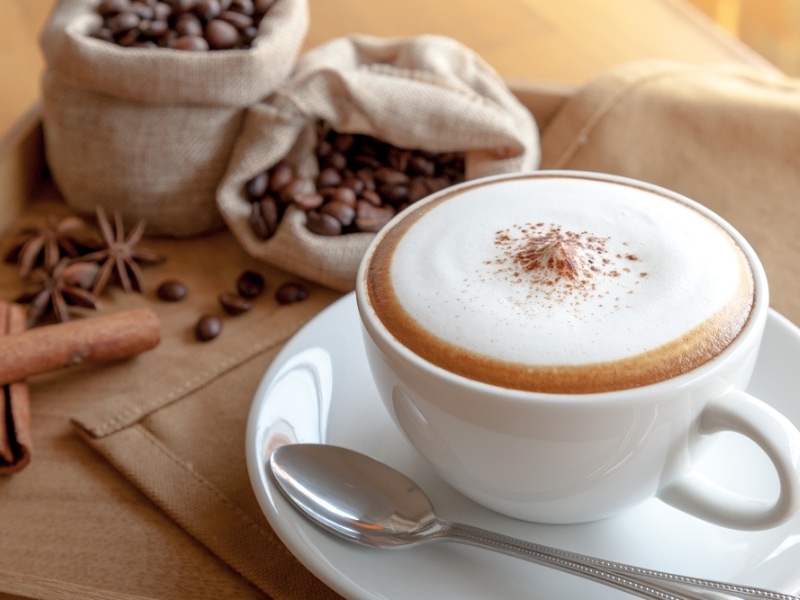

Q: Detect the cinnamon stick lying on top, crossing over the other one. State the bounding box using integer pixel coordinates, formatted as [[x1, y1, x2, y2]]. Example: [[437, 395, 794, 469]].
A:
[[0, 308, 161, 386]]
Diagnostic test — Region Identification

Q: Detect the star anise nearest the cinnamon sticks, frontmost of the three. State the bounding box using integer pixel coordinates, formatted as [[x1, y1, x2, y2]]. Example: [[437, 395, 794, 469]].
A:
[[16, 258, 100, 328]]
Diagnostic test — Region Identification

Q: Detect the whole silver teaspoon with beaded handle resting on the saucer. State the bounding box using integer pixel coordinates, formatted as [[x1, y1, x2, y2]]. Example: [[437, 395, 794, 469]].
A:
[[270, 444, 800, 600]]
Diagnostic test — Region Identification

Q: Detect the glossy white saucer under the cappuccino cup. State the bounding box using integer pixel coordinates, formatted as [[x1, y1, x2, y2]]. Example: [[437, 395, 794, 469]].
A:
[[246, 294, 800, 600]]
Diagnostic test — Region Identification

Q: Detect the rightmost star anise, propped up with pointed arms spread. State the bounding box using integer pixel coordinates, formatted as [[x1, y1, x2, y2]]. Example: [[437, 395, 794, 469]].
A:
[[81, 207, 165, 296]]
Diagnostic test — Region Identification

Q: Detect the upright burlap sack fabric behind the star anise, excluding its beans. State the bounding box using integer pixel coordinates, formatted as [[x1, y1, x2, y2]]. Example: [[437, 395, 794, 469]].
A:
[[41, 0, 309, 237]]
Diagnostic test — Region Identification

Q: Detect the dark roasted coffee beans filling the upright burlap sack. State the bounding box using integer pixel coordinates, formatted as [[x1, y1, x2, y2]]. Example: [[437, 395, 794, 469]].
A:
[[90, 0, 278, 51]]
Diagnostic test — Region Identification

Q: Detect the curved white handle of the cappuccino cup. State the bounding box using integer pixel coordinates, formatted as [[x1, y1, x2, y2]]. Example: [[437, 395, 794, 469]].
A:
[[658, 388, 800, 530]]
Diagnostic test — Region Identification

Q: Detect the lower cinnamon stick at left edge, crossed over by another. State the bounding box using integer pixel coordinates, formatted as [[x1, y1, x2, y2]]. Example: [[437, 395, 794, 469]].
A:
[[0, 302, 33, 475]]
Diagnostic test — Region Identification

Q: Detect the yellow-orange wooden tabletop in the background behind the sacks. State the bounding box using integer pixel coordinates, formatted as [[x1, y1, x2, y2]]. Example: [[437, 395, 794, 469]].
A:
[[0, 0, 771, 150]]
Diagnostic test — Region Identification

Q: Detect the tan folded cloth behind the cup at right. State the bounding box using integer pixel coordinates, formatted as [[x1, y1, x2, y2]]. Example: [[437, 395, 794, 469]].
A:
[[541, 61, 800, 322]]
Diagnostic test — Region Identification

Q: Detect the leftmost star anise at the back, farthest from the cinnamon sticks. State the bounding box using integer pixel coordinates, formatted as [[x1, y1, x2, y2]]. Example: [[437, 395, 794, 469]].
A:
[[5, 215, 100, 279]]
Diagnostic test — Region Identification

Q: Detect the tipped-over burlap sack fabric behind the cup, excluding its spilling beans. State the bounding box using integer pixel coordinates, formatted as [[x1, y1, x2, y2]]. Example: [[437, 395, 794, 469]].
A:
[[218, 36, 539, 291]]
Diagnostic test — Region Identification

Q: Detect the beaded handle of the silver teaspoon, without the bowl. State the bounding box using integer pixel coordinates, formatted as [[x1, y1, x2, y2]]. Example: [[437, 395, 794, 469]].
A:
[[440, 521, 800, 600]]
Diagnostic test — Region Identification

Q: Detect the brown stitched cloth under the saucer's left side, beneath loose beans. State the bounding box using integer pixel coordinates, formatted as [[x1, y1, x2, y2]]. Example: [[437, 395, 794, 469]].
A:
[[65, 226, 344, 600]]
